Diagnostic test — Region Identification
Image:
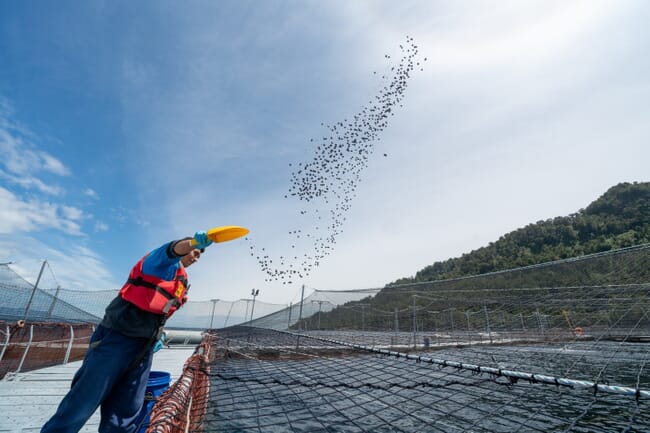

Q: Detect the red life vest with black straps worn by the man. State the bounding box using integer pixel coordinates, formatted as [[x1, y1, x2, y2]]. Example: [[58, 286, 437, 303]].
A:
[[120, 254, 189, 317]]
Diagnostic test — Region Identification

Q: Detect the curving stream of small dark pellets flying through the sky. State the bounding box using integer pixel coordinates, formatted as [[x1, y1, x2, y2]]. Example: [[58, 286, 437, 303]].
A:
[[246, 36, 427, 284]]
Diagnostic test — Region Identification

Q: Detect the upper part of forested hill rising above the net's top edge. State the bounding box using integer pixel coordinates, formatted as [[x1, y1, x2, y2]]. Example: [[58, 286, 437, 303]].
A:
[[390, 182, 650, 285]]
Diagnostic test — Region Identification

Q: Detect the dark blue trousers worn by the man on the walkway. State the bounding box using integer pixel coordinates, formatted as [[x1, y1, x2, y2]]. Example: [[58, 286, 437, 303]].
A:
[[41, 325, 153, 433]]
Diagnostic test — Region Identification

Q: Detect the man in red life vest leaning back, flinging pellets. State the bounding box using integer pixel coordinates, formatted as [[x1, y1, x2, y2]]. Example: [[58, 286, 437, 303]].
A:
[[41, 232, 212, 433]]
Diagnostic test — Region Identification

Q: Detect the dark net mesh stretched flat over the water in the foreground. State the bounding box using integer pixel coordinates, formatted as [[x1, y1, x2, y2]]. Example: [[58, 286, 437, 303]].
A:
[[193, 328, 650, 432]]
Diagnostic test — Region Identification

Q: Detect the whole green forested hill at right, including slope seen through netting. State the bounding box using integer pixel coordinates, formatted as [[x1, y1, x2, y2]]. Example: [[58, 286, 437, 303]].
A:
[[294, 183, 650, 330]]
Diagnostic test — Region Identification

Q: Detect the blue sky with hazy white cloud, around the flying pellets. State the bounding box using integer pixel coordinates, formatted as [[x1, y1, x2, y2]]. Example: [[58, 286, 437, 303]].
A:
[[0, 0, 650, 303]]
